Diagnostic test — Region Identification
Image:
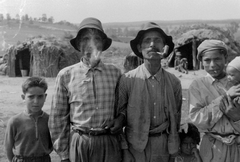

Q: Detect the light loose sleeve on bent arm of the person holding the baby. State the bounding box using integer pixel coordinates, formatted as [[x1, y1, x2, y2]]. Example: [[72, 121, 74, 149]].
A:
[[188, 81, 223, 130]]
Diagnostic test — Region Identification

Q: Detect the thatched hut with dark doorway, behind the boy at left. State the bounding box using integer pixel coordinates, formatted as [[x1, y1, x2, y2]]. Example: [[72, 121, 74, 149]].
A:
[[8, 37, 80, 77]]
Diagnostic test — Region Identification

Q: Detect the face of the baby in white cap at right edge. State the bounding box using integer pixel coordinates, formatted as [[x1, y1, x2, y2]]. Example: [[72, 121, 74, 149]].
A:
[[226, 66, 240, 85]]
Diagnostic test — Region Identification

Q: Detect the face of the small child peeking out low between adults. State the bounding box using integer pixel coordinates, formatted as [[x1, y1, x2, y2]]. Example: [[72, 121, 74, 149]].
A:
[[181, 137, 197, 155]]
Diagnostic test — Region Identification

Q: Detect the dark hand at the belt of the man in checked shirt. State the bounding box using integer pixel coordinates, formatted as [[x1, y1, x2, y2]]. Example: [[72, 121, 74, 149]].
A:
[[103, 114, 125, 134]]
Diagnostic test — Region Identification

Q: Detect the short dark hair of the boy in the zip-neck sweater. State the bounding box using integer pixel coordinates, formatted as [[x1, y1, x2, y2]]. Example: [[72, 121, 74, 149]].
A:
[[22, 77, 48, 94]]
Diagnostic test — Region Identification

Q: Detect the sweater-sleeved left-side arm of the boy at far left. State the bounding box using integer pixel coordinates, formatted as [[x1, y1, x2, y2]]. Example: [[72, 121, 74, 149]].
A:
[[4, 119, 14, 162]]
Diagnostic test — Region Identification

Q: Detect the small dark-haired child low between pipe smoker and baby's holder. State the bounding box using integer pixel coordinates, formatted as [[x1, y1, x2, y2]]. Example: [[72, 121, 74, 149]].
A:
[[175, 123, 202, 162]]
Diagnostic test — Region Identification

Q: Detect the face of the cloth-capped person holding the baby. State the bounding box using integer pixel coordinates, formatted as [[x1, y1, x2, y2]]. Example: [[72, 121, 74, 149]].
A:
[[202, 50, 226, 79]]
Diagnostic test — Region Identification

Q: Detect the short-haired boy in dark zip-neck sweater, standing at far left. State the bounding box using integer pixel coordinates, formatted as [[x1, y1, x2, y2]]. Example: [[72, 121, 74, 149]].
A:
[[4, 77, 53, 162]]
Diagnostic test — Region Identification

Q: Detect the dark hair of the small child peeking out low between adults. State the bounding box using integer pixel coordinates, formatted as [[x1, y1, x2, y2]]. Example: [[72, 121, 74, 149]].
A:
[[179, 123, 200, 145]]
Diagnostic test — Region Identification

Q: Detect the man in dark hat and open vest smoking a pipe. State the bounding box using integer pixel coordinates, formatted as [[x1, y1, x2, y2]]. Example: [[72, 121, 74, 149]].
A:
[[118, 22, 182, 162]]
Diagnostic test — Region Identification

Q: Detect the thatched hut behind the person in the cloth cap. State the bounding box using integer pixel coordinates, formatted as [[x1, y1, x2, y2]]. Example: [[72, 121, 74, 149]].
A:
[[169, 26, 240, 70]]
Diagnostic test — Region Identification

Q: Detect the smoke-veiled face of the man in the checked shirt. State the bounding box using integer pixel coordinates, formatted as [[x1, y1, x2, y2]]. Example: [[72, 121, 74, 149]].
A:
[[78, 30, 104, 65]]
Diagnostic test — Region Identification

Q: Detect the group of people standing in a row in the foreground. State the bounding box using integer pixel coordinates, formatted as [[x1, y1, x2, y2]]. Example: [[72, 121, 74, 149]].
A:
[[5, 18, 240, 162]]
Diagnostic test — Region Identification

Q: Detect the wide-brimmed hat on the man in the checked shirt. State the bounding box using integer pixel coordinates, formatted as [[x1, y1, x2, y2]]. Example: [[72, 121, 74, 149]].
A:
[[70, 17, 112, 51]]
